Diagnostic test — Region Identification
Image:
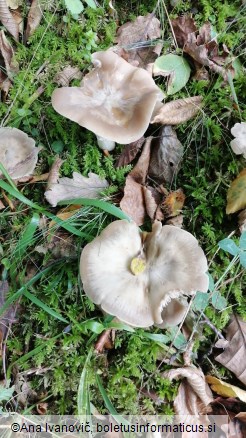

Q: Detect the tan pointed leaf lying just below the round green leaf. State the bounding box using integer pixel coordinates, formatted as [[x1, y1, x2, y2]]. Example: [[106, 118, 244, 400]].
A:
[[151, 96, 202, 125]]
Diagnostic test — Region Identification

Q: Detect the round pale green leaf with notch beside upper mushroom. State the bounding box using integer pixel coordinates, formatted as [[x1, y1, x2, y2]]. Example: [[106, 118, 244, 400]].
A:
[[153, 54, 191, 95]]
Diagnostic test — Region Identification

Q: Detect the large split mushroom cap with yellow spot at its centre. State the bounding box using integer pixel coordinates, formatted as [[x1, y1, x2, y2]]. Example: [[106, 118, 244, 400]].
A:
[[80, 220, 208, 327]]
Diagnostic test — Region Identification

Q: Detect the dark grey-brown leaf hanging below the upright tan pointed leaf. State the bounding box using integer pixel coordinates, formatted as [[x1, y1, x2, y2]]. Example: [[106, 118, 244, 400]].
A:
[[148, 126, 183, 184]]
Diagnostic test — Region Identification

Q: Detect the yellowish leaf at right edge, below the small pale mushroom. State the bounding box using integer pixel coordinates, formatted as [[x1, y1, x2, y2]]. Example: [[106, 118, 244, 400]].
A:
[[226, 169, 246, 214]]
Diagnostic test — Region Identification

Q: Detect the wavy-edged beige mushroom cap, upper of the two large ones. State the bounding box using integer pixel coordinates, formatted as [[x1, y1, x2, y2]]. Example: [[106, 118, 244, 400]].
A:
[[52, 51, 164, 144]]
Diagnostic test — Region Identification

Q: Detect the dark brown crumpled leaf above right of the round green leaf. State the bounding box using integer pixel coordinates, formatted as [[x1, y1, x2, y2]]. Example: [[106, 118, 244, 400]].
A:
[[172, 16, 234, 79]]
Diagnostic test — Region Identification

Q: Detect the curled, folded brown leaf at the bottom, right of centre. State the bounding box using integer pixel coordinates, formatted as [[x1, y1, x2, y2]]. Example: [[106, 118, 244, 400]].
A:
[[163, 366, 213, 415]]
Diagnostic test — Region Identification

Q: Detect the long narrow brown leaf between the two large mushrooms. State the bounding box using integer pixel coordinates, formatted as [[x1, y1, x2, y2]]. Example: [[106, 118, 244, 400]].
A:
[[120, 137, 152, 226]]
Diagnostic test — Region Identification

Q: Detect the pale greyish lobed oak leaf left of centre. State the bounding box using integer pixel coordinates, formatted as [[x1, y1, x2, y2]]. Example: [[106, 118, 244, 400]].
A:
[[44, 172, 108, 207]]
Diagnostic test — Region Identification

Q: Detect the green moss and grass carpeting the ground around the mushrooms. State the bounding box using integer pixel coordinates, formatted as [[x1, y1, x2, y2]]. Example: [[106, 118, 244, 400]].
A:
[[0, 0, 246, 414]]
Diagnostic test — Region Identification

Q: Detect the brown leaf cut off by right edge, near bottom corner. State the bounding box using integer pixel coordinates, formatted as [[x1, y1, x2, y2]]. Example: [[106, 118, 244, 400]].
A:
[[215, 316, 246, 385]]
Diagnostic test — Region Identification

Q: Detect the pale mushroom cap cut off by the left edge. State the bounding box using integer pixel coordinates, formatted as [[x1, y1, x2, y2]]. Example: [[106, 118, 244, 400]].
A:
[[0, 128, 40, 179]]
